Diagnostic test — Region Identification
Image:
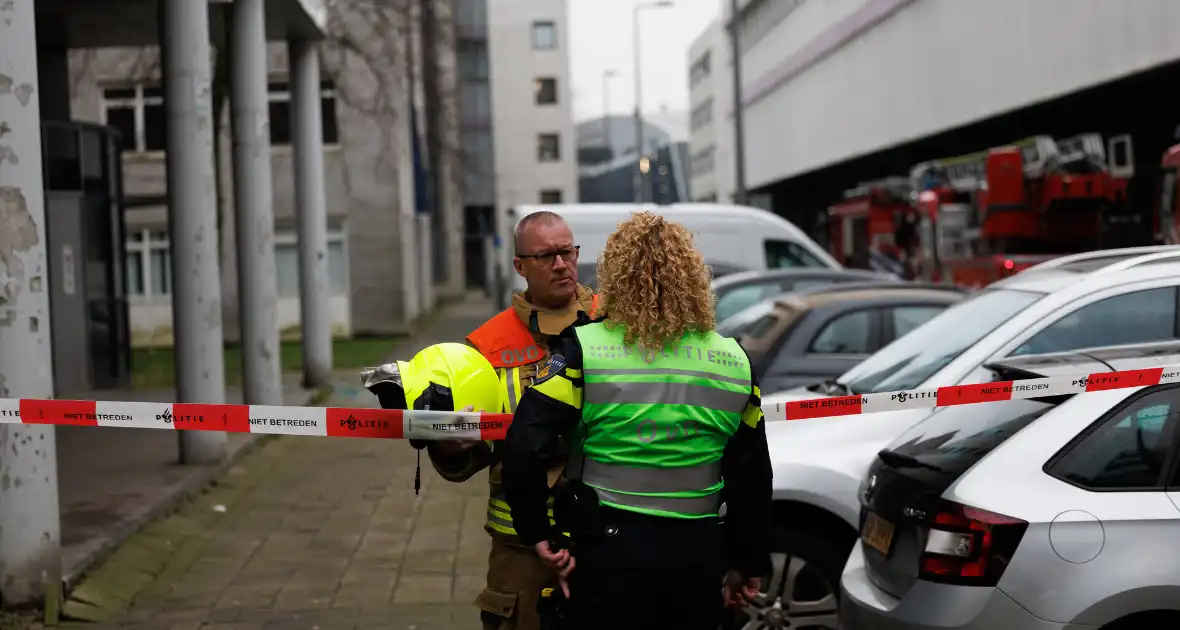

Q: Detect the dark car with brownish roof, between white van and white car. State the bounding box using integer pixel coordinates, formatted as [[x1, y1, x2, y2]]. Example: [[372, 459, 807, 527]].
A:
[[719, 280, 966, 392]]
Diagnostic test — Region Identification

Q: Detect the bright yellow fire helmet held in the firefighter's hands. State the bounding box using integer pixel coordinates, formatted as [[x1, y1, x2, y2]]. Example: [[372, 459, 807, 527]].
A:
[[361, 343, 504, 413]]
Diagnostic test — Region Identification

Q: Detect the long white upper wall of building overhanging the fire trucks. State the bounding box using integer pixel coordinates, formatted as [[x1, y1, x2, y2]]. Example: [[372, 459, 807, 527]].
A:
[[742, 0, 1180, 188]]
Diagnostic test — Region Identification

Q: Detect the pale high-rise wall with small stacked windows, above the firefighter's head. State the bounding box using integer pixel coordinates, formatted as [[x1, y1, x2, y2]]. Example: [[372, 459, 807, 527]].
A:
[[487, 0, 578, 212]]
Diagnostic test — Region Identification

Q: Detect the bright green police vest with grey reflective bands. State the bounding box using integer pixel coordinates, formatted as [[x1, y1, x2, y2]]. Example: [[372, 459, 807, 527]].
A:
[[575, 322, 753, 518]]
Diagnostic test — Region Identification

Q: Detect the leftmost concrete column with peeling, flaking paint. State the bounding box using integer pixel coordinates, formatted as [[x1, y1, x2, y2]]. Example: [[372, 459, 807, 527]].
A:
[[0, 1, 61, 605]]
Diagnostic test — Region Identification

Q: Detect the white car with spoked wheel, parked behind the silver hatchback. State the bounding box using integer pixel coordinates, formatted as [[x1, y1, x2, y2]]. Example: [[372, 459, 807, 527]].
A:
[[745, 245, 1180, 629]]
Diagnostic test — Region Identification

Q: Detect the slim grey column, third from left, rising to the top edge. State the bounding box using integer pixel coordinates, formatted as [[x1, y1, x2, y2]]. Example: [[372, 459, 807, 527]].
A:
[[229, 0, 283, 405]]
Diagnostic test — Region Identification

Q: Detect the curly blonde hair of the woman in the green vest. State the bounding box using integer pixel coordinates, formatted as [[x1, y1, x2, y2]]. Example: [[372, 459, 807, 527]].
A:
[[598, 212, 717, 348]]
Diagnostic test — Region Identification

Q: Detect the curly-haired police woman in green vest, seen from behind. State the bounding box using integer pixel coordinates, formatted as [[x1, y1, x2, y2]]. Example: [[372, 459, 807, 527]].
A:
[[502, 212, 772, 630]]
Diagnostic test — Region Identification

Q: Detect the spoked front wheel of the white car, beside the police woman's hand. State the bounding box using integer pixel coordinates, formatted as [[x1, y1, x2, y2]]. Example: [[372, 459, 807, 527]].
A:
[[732, 527, 848, 630]]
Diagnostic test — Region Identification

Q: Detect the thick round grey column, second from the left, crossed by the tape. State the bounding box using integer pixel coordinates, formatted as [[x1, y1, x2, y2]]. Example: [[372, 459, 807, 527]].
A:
[[159, 0, 225, 464]]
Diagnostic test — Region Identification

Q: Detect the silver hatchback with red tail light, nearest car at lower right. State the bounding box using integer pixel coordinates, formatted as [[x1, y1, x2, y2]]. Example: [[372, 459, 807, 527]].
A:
[[840, 342, 1180, 630]]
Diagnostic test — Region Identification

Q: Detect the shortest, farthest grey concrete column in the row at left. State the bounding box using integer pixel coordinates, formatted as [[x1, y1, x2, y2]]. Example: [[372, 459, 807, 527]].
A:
[[287, 39, 332, 387]]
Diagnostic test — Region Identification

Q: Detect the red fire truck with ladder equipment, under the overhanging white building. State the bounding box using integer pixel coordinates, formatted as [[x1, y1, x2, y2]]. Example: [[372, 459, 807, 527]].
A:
[[828, 133, 1137, 287]]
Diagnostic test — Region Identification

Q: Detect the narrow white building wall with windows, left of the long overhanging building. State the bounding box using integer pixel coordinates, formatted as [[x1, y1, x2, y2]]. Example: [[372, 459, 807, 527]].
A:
[[687, 19, 735, 203]]
